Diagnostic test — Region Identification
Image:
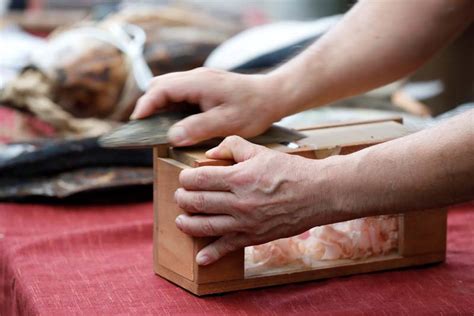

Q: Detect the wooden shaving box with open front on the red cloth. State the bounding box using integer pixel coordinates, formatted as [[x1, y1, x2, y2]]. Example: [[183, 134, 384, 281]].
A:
[[153, 120, 446, 295]]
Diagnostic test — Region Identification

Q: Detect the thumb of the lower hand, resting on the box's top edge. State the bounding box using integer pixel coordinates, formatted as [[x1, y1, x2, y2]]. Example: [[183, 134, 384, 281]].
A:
[[206, 136, 266, 162]]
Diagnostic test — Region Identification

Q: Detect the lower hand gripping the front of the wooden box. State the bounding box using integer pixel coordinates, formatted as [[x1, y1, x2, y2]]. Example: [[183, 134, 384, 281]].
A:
[[175, 136, 340, 265]]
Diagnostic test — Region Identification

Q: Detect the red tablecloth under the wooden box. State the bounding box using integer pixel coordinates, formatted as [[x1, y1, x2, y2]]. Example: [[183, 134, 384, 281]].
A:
[[0, 203, 474, 315]]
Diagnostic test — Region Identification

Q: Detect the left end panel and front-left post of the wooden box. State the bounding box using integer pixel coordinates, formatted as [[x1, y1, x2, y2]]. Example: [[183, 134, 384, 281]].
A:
[[154, 158, 244, 283]]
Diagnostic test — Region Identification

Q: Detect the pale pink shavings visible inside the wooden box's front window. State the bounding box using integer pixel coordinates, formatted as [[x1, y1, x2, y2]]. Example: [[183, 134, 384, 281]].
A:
[[245, 215, 399, 276]]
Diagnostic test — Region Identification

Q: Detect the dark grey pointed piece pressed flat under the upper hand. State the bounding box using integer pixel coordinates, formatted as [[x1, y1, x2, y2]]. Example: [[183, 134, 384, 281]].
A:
[[99, 112, 305, 148]]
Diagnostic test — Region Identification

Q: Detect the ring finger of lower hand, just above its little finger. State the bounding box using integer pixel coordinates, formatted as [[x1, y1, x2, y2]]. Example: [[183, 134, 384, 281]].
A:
[[176, 215, 238, 237]]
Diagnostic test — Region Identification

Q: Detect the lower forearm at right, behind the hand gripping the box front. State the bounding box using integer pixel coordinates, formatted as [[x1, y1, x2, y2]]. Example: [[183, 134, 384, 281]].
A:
[[326, 110, 474, 221]]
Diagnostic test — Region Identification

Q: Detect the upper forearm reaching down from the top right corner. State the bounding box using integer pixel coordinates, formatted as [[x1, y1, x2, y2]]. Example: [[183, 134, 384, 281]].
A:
[[269, 0, 474, 118]]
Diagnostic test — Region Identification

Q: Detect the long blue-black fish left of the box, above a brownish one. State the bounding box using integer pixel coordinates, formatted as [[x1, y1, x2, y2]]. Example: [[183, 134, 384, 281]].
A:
[[0, 138, 153, 180]]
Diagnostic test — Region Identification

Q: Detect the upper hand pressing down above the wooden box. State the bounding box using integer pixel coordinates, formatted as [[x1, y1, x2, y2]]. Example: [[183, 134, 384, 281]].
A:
[[131, 68, 282, 146]]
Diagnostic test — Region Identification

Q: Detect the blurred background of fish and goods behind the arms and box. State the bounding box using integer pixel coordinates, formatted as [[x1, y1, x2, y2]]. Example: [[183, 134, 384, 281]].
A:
[[0, 0, 474, 200]]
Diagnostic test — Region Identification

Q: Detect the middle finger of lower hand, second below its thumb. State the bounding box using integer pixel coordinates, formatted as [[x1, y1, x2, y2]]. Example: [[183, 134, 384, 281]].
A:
[[175, 189, 237, 214]]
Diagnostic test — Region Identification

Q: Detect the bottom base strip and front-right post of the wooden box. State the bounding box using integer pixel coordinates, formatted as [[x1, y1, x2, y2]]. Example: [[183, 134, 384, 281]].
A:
[[158, 209, 447, 295]]
